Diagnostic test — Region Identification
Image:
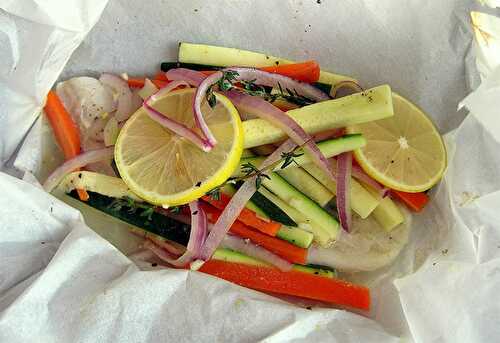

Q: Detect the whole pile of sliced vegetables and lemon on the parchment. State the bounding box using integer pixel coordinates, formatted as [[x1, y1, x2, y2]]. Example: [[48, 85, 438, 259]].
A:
[[44, 43, 446, 310]]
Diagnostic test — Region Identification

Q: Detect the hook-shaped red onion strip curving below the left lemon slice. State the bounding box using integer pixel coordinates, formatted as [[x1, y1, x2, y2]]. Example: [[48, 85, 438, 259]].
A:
[[144, 200, 207, 267]]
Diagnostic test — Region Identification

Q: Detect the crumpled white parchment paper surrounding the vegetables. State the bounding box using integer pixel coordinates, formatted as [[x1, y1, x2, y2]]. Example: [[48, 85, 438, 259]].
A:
[[0, 0, 500, 342]]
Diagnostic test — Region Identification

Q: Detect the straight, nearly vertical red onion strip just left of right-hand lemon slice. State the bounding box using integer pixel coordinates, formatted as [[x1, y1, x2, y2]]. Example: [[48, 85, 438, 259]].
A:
[[337, 152, 352, 232]]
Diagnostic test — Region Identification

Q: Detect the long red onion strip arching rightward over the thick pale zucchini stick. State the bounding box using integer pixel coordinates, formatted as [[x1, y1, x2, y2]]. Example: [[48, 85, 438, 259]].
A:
[[223, 91, 335, 180]]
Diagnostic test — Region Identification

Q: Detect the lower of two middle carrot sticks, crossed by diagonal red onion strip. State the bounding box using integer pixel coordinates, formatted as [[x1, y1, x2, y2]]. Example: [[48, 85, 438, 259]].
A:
[[201, 203, 307, 264]]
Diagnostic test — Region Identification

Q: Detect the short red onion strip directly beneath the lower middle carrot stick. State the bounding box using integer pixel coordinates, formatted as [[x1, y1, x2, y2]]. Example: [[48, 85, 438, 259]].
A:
[[221, 235, 292, 272]]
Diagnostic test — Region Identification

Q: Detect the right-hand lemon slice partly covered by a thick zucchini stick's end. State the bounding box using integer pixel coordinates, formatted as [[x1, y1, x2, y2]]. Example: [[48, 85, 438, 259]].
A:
[[347, 93, 446, 192]]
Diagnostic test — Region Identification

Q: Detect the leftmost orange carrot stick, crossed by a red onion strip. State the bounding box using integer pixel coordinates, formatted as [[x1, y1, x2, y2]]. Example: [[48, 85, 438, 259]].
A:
[[44, 91, 89, 201]]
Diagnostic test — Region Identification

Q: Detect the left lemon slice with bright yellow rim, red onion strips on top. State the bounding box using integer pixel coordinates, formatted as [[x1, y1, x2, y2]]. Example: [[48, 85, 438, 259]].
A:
[[115, 88, 243, 207]]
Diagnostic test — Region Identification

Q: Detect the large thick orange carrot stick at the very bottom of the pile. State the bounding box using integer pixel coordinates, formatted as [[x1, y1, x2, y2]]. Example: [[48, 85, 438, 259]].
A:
[[199, 260, 370, 310]]
